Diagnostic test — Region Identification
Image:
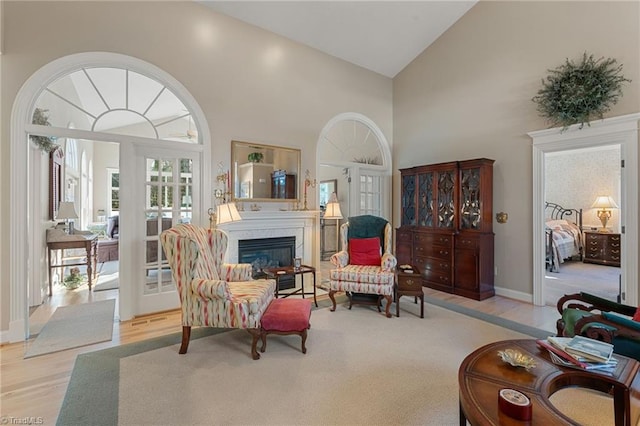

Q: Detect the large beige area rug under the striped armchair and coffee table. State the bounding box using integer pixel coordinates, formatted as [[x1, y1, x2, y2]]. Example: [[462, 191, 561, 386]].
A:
[[107, 302, 613, 425]]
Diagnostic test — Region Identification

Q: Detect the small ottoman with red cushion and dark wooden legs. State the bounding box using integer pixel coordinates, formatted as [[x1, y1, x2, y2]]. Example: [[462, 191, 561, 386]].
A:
[[260, 299, 311, 354]]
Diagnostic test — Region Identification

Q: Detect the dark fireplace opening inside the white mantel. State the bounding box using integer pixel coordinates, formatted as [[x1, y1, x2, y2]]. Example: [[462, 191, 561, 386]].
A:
[[238, 237, 296, 290]]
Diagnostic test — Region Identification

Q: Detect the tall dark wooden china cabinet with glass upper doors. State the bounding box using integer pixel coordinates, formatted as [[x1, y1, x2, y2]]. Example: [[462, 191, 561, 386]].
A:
[[396, 158, 495, 300]]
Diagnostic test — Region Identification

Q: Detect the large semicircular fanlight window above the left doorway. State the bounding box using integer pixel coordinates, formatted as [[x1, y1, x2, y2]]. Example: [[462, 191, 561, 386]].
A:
[[33, 67, 200, 144]]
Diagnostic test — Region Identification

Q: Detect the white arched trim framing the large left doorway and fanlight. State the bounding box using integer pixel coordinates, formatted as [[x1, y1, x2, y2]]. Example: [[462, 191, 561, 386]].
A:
[[7, 52, 211, 342]]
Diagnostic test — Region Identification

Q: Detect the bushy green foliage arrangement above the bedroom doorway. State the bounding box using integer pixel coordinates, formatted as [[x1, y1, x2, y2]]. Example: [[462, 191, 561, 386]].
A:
[[532, 52, 631, 130]]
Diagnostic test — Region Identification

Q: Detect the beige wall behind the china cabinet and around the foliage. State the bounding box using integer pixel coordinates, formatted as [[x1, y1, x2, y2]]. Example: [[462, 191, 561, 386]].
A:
[[393, 1, 640, 295]]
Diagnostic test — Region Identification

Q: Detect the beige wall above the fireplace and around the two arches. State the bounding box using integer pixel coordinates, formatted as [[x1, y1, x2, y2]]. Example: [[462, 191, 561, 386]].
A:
[[0, 1, 392, 330]]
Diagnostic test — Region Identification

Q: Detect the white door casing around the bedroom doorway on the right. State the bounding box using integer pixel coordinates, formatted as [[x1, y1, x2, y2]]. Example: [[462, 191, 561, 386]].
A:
[[528, 113, 640, 306]]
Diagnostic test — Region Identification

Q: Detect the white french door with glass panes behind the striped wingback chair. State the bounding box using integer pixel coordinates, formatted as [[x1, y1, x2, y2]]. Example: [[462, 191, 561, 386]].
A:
[[129, 147, 201, 315]]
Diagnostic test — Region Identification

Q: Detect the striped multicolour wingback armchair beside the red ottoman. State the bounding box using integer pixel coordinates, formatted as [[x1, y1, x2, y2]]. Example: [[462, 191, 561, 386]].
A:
[[160, 224, 276, 359]]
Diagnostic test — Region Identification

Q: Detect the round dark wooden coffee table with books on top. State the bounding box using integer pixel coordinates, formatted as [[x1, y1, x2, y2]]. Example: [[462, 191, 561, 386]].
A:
[[458, 339, 640, 425]]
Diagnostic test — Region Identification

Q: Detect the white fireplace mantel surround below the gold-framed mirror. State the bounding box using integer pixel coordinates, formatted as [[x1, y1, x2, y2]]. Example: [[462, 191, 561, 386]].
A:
[[218, 210, 320, 265]]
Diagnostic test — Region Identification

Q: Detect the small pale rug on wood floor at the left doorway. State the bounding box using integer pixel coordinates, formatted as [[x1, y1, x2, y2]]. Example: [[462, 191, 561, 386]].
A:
[[24, 299, 116, 358]]
